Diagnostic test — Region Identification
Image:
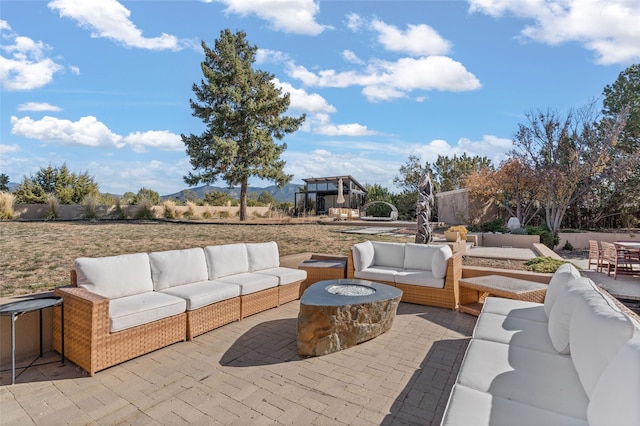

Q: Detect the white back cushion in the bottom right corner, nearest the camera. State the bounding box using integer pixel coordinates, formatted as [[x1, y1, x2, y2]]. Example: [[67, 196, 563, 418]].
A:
[[587, 329, 640, 426]]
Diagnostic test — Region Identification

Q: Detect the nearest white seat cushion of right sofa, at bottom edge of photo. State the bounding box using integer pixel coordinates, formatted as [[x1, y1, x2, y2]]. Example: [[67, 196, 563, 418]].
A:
[[442, 385, 587, 426]]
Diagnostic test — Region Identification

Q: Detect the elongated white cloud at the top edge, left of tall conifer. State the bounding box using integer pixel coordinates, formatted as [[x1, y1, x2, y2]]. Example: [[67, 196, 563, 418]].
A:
[[48, 0, 192, 50]]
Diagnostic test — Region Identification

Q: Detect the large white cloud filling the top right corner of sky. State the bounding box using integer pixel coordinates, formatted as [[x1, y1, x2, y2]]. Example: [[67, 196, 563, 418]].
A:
[[469, 0, 640, 65]]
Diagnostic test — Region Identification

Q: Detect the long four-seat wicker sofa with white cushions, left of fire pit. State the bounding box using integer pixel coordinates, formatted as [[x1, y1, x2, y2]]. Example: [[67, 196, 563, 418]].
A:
[[53, 241, 306, 375]]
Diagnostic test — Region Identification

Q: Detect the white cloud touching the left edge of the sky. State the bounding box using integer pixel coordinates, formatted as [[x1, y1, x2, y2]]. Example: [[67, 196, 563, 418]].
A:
[[0, 21, 63, 90]]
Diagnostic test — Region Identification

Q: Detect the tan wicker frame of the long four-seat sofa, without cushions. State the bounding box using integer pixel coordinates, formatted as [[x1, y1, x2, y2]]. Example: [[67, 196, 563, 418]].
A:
[[52, 253, 304, 376]]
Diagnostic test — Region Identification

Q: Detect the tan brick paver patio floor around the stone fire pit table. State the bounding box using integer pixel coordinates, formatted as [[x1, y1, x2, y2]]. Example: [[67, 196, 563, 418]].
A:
[[0, 301, 475, 426]]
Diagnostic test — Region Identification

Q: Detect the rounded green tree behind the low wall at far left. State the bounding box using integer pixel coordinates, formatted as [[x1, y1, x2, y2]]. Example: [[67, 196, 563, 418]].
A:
[[14, 164, 100, 204]]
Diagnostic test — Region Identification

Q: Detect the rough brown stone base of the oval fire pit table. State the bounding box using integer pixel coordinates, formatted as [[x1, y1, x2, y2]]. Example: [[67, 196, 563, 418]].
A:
[[298, 294, 402, 356]]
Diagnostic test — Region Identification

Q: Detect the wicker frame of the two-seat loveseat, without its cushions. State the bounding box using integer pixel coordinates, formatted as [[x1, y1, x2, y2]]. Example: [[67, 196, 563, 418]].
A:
[[347, 250, 474, 309]]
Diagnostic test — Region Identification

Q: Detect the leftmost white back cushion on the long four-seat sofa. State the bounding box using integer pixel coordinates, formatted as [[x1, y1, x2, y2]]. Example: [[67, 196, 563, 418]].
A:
[[75, 253, 153, 299]]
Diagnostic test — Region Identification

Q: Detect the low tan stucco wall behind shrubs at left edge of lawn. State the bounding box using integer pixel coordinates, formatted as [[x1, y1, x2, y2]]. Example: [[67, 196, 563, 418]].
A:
[[13, 204, 271, 220]]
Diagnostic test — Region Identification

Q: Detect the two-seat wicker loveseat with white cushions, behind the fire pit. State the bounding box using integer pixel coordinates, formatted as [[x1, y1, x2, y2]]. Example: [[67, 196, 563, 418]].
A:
[[347, 241, 473, 309]]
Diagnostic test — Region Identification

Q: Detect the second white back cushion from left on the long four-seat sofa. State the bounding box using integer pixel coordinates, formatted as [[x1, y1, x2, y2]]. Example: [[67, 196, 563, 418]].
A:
[[149, 248, 209, 291]]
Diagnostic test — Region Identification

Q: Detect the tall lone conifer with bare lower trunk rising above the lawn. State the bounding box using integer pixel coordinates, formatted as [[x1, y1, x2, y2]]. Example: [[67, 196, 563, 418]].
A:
[[181, 29, 306, 221]]
